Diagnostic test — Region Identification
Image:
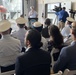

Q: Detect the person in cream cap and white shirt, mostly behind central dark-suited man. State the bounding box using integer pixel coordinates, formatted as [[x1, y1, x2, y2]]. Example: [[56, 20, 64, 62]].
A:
[[33, 22, 48, 51]]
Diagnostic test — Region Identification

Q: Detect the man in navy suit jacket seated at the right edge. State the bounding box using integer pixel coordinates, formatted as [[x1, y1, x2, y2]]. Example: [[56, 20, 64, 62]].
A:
[[53, 22, 76, 73]]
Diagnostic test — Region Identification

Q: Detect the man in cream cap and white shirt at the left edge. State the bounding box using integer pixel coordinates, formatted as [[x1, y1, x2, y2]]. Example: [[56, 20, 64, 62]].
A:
[[0, 20, 21, 72]]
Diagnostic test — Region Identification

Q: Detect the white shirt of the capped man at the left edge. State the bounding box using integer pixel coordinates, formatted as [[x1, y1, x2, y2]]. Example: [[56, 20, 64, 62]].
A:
[[0, 35, 21, 66]]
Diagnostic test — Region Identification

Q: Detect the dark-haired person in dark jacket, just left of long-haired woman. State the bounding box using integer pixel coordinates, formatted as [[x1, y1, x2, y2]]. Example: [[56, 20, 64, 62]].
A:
[[42, 18, 51, 40]]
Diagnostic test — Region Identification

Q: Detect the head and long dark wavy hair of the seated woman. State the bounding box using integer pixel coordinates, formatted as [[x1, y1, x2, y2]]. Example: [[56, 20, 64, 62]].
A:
[[50, 25, 63, 48]]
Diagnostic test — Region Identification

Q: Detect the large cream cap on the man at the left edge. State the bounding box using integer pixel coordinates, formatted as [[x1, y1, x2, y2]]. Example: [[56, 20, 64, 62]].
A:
[[0, 20, 11, 32]]
